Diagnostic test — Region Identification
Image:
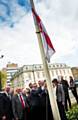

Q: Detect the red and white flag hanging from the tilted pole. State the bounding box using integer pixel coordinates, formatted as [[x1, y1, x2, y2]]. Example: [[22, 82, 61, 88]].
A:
[[32, 8, 55, 62]]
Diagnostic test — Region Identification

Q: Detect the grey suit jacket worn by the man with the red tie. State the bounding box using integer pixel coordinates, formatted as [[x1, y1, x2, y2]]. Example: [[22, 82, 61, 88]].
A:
[[12, 94, 23, 119]]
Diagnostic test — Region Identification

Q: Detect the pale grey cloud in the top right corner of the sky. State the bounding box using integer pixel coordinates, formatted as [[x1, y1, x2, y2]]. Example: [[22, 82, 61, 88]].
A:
[[38, 0, 78, 27]]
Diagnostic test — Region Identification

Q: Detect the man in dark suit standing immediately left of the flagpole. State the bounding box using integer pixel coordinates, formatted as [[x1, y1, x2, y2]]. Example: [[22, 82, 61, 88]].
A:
[[39, 81, 54, 120]]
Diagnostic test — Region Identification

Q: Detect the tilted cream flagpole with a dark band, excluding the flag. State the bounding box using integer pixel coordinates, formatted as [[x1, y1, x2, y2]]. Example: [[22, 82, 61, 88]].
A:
[[30, 0, 61, 120]]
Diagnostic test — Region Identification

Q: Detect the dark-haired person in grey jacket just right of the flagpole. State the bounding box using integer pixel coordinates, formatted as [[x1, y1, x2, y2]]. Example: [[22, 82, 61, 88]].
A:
[[52, 79, 67, 120]]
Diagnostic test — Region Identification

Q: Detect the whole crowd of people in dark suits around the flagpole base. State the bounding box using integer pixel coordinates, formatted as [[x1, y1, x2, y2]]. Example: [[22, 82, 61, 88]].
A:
[[0, 76, 78, 120]]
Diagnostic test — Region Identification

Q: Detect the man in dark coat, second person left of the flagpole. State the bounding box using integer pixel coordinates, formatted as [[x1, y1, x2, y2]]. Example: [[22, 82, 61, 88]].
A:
[[29, 83, 41, 120]]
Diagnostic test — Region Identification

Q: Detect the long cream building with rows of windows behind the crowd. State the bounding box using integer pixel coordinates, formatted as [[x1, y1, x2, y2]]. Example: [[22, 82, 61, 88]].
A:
[[11, 64, 73, 87]]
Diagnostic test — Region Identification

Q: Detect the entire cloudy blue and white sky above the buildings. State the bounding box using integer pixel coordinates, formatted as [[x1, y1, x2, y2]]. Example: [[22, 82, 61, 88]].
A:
[[0, 0, 78, 68]]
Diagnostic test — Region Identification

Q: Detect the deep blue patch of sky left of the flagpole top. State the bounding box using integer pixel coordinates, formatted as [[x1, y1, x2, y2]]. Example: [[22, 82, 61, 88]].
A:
[[0, 0, 30, 27]]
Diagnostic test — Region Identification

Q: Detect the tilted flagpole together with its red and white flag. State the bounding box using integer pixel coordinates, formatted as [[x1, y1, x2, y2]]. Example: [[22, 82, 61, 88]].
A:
[[30, 0, 60, 120]]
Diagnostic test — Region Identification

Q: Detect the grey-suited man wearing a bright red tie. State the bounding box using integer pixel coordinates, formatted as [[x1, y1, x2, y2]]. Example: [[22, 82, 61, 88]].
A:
[[12, 88, 25, 120]]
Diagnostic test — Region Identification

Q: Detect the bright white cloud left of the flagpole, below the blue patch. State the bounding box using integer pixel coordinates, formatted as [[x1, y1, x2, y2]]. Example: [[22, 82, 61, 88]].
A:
[[0, 11, 40, 67]]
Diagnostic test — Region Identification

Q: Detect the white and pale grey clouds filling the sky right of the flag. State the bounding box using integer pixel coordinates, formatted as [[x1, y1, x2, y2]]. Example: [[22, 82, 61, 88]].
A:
[[36, 0, 78, 65]]
